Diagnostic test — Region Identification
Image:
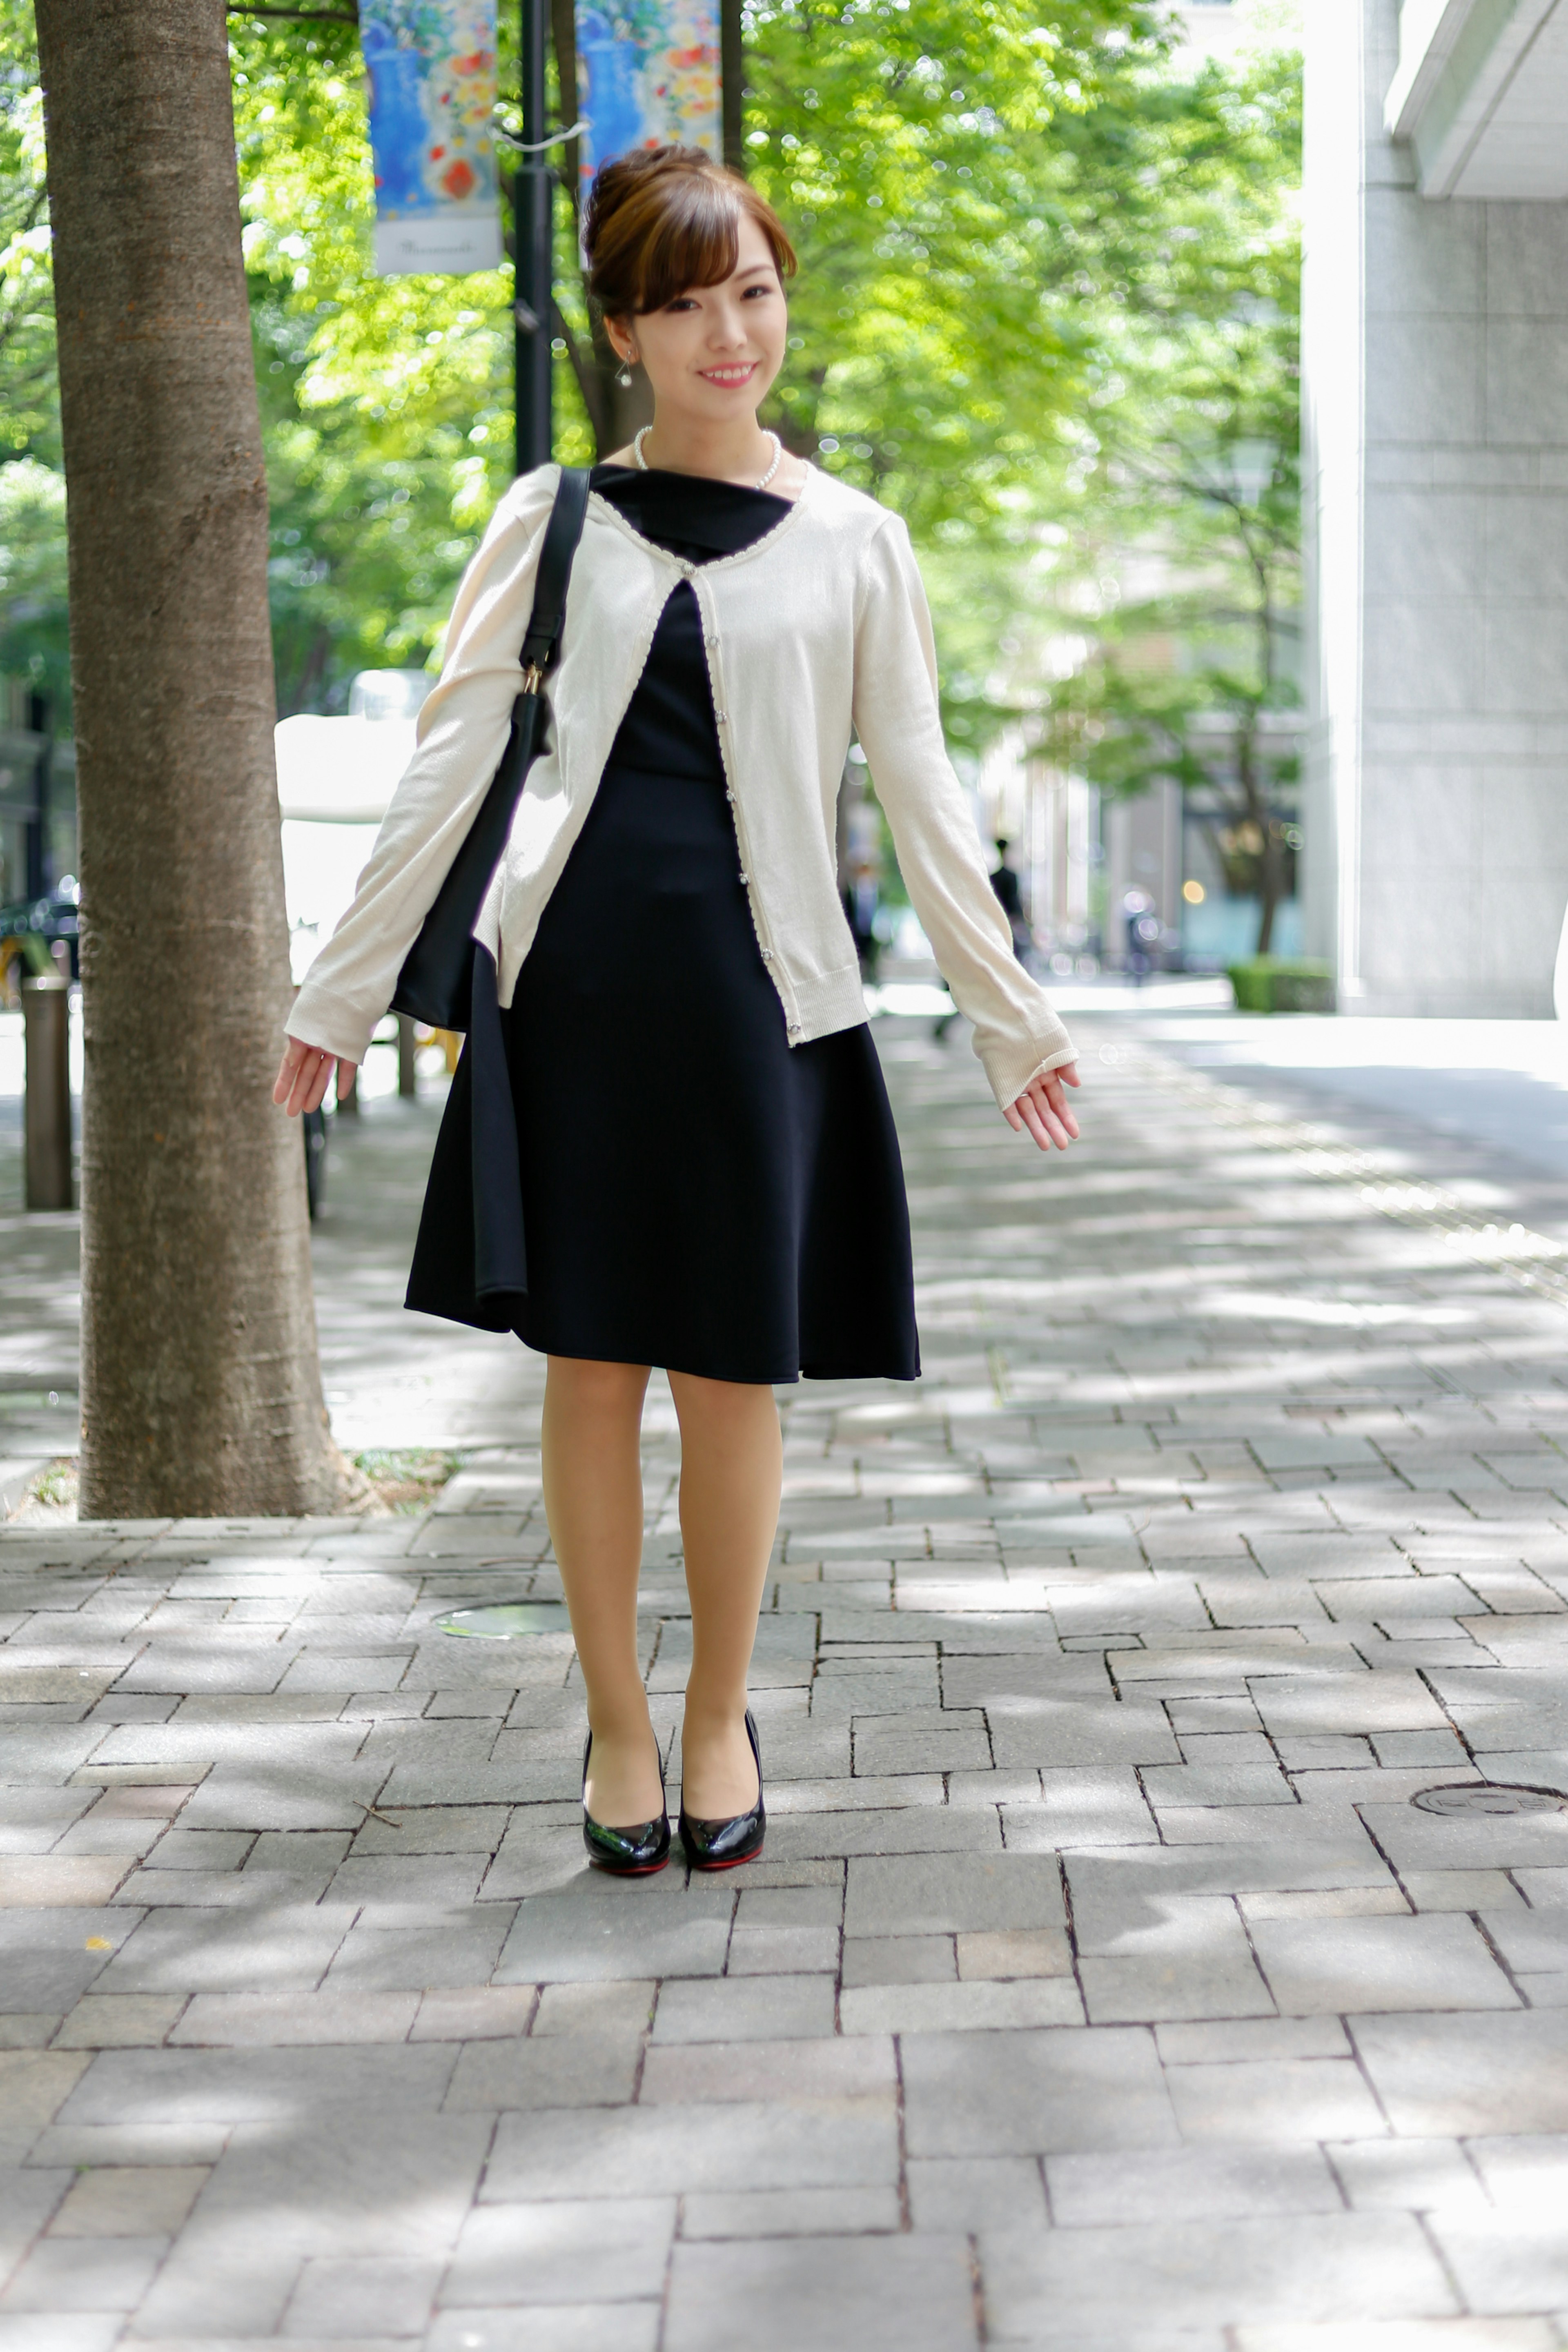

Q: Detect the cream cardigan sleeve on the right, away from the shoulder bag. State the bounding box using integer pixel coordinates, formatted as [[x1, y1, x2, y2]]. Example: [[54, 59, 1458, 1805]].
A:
[[853, 515, 1077, 1108]]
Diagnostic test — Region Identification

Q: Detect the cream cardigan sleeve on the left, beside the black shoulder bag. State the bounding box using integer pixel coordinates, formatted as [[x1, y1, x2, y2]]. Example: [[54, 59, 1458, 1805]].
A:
[[287, 466, 559, 1061]]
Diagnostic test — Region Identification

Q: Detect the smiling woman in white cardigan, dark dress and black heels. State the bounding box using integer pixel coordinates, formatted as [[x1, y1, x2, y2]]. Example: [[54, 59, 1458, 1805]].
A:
[[275, 148, 1077, 1872]]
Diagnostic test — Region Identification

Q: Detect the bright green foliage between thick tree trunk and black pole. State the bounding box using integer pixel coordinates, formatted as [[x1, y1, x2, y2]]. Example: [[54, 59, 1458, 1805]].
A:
[[230, 16, 512, 713]]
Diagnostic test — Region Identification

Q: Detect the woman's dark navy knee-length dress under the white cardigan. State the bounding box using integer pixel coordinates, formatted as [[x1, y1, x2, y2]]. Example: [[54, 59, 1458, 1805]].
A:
[[407, 466, 919, 1383]]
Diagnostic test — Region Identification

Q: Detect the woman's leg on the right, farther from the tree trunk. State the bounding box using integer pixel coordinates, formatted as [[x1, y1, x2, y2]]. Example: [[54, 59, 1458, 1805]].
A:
[[670, 1371, 783, 1820]]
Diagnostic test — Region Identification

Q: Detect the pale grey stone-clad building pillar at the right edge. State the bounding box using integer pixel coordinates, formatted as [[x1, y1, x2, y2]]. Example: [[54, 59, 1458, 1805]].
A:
[[1302, 0, 1568, 1018]]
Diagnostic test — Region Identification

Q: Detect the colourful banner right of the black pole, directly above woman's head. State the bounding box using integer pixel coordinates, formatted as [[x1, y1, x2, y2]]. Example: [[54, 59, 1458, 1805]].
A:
[[576, 0, 724, 179]]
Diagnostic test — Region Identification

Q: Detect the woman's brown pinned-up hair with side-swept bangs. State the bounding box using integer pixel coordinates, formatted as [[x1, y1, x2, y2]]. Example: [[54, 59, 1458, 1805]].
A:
[[583, 146, 795, 318]]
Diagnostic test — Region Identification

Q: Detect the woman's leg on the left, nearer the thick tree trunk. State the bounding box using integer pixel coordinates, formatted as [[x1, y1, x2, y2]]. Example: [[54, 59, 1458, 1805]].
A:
[[543, 1355, 663, 1828]]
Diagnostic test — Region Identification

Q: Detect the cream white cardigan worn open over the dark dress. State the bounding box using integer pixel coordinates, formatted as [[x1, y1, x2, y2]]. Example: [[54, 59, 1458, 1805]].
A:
[[289, 466, 1077, 1105]]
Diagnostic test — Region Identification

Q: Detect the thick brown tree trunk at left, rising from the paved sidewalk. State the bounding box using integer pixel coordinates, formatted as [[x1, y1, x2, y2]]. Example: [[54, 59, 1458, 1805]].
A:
[[38, 0, 341, 1519]]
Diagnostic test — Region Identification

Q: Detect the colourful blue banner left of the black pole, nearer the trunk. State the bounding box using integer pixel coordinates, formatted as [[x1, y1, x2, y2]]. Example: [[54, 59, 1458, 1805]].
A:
[[360, 0, 501, 278]]
